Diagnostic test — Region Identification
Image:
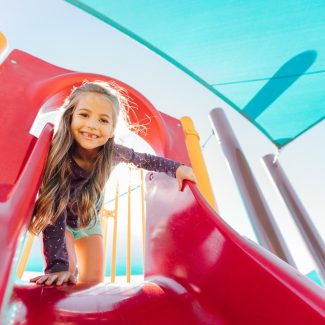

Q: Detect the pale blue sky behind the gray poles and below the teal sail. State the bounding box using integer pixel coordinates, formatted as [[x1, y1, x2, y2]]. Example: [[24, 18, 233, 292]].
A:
[[0, 0, 325, 273]]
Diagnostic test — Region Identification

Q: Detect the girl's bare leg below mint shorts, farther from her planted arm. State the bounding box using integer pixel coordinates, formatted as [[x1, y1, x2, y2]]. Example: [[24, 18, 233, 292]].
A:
[[74, 235, 104, 283]]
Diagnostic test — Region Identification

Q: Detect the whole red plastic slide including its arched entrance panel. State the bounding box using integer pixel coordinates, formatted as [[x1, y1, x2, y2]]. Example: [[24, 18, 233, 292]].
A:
[[0, 50, 325, 325]]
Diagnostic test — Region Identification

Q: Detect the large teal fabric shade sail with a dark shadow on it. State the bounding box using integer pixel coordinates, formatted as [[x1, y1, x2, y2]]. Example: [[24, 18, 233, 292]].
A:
[[66, 0, 325, 148]]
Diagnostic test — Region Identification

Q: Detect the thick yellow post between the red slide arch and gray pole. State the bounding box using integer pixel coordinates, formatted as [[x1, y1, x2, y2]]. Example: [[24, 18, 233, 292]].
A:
[[180, 116, 218, 211]]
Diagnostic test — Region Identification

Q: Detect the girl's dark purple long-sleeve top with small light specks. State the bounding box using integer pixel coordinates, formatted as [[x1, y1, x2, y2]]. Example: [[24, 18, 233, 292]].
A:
[[43, 144, 181, 273]]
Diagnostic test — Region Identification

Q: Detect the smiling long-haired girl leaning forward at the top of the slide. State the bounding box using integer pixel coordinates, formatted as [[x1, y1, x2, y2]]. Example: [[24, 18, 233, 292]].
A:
[[29, 81, 196, 285]]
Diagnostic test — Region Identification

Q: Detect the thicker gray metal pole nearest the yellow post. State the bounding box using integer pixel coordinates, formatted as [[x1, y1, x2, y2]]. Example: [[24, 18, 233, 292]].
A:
[[210, 108, 296, 267]]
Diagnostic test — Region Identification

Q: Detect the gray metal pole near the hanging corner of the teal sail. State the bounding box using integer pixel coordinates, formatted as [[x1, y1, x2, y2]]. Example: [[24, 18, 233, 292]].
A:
[[262, 154, 325, 283]]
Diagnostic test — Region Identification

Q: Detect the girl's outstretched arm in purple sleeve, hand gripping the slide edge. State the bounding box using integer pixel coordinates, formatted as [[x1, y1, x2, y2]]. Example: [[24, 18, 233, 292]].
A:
[[113, 144, 196, 190]]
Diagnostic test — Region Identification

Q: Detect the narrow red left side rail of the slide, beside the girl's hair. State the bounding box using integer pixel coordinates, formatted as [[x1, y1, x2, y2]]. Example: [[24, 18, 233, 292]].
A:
[[0, 124, 53, 313]]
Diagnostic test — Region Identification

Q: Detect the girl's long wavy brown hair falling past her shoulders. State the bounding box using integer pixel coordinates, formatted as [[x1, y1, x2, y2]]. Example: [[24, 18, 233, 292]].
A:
[[29, 81, 129, 234]]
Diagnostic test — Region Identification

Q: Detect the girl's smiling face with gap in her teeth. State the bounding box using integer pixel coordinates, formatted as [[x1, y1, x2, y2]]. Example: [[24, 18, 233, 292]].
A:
[[71, 92, 116, 153]]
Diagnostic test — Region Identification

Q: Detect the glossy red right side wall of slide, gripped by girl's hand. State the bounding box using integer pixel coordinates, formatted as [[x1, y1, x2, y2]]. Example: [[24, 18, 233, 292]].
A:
[[146, 174, 325, 324]]
